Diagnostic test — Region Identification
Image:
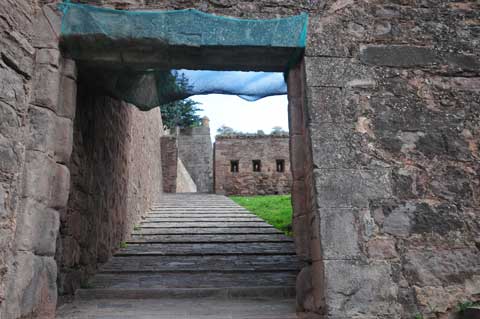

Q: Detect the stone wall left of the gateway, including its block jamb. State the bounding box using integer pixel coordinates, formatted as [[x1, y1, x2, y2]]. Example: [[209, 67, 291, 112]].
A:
[[0, 0, 75, 319]]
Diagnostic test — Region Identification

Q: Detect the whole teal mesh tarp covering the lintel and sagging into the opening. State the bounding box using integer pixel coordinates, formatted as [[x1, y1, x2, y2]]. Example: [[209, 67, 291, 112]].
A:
[[60, 2, 308, 110]]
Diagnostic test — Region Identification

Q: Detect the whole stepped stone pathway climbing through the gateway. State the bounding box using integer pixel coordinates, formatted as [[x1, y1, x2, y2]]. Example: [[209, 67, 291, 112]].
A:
[[57, 194, 299, 319]]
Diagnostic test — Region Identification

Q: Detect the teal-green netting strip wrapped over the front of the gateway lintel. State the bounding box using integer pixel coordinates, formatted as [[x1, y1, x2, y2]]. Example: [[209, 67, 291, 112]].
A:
[[61, 2, 307, 48]]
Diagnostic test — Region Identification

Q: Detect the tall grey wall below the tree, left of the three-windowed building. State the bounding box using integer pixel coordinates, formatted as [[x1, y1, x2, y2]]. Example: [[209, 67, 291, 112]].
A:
[[177, 126, 213, 193]]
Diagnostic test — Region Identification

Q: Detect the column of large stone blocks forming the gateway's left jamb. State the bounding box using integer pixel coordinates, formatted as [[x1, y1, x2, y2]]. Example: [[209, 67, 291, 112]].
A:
[[6, 5, 76, 318]]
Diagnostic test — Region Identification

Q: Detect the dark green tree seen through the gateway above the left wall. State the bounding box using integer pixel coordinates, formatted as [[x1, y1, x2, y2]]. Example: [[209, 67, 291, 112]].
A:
[[157, 71, 201, 129]]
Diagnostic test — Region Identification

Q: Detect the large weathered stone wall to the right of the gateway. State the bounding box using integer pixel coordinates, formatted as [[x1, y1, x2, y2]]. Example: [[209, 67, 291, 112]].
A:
[[305, 1, 480, 318]]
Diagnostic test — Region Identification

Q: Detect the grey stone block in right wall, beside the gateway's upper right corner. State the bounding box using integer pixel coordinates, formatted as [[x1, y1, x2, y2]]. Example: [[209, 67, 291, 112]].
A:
[[305, 57, 374, 88]]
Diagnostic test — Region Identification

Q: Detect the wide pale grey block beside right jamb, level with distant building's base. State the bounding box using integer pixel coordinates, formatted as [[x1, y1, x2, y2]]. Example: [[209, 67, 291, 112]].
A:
[[314, 169, 392, 207]]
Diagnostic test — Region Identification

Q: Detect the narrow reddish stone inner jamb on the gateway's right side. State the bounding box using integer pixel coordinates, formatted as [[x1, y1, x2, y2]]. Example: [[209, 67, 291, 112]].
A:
[[287, 60, 326, 318]]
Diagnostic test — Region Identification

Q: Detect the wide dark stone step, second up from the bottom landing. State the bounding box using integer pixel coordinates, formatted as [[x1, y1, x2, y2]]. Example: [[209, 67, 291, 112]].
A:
[[89, 271, 296, 289]]
